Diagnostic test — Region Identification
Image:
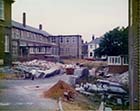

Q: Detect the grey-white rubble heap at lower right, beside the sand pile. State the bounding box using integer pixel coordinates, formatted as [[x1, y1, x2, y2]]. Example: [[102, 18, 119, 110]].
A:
[[75, 79, 127, 95]]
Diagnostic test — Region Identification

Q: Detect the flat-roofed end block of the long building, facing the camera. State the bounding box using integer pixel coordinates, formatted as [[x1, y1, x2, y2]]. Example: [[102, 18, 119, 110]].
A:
[[48, 35, 82, 58]]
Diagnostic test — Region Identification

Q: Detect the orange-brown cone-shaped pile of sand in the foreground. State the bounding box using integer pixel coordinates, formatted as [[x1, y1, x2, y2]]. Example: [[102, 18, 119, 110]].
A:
[[43, 80, 76, 99]]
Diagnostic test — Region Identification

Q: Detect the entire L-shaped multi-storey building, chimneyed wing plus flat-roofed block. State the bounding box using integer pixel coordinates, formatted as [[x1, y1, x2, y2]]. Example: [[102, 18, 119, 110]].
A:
[[12, 13, 82, 61]]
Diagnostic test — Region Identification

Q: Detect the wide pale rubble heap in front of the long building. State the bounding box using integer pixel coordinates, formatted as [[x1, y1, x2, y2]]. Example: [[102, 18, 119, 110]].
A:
[[14, 60, 68, 79]]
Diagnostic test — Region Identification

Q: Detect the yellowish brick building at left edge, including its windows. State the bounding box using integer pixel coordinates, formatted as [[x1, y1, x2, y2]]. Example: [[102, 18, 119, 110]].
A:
[[0, 0, 14, 65]]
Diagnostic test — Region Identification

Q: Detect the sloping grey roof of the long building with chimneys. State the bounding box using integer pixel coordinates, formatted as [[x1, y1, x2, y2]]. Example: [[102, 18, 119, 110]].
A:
[[12, 20, 50, 36]]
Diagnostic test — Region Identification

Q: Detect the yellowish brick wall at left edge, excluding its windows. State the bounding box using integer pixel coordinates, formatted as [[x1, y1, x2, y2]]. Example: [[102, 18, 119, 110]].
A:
[[0, 0, 13, 65]]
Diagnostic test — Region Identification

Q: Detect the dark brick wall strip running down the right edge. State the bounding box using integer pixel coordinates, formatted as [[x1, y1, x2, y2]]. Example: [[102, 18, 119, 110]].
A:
[[129, 0, 140, 110]]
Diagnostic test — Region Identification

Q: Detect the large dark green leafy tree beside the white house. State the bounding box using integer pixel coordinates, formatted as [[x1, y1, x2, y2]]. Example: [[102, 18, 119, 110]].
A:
[[94, 27, 128, 57]]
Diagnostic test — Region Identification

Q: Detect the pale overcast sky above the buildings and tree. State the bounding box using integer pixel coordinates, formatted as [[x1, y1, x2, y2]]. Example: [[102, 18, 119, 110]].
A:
[[12, 0, 128, 41]]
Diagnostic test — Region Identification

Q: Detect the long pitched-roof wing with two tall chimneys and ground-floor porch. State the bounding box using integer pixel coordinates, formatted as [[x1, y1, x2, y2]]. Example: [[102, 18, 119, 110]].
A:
[[12, 13, 58, 61]]
